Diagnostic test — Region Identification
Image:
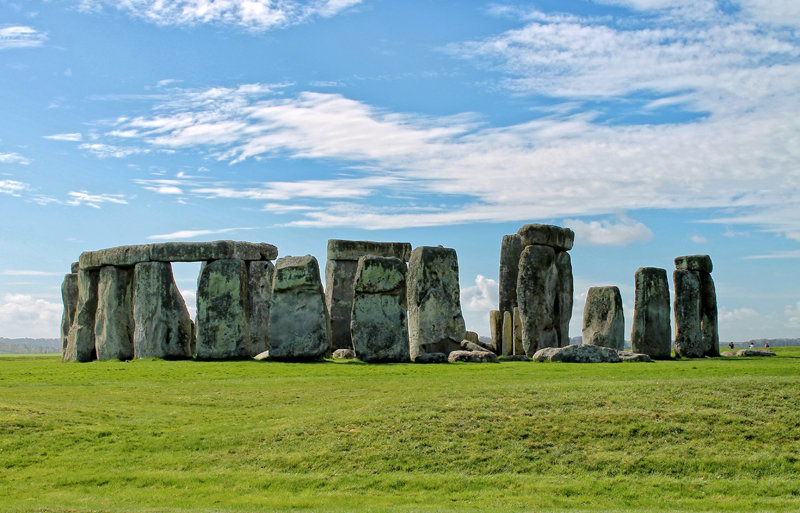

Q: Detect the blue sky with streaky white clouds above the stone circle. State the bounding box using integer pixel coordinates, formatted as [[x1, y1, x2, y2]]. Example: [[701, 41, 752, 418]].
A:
[[0, 0, 800, 341]]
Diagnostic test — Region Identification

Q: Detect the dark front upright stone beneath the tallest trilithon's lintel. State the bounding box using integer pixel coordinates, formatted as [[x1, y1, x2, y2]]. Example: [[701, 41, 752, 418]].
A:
[[517, 245, 560, 356]]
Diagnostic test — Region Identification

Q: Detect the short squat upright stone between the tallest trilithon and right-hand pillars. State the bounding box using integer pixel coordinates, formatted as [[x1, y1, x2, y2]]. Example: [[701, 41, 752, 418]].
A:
[[583, 287, 625, 349]]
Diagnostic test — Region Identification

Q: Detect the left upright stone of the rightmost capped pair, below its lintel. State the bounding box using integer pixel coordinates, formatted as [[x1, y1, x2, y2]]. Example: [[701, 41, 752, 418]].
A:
[[672, 269, 706, 358]]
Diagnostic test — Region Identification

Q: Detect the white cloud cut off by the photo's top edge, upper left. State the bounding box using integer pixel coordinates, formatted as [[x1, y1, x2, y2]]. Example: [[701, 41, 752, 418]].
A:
[[79, 0, 362, 32]]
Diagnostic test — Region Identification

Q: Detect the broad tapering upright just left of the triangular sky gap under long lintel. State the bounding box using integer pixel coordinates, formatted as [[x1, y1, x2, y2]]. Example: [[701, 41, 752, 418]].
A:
[[133, 262, 194, 358]]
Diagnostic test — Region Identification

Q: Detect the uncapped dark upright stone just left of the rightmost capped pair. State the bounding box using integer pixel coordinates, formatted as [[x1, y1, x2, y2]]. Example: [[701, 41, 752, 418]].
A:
[[631, 267, 672, 358]]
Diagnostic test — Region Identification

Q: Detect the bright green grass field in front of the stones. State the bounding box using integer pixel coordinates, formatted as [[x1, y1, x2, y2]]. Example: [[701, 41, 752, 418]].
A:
[[0, 348, 800, 512]]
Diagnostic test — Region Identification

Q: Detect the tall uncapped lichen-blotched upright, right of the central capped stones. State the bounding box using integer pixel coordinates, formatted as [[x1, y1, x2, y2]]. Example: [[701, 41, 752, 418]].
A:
[[408, 246, 466, 360]]
